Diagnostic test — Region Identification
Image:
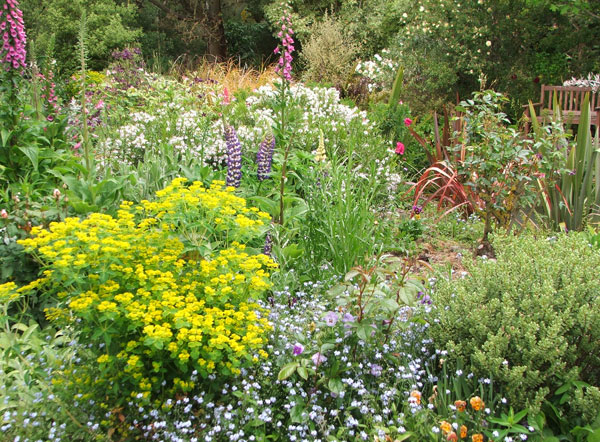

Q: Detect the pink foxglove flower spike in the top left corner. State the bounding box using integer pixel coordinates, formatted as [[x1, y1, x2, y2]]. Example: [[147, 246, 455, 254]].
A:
[[0, 0, 27, 70]]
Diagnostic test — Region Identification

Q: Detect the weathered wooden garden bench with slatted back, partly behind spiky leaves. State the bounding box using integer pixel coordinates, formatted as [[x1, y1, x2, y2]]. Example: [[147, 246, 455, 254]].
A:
[[524, 84, 600, 133]]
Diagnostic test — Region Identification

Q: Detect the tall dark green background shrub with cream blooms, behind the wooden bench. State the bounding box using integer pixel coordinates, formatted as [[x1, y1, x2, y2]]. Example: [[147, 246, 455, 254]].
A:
[[391, 0, 598, 118]]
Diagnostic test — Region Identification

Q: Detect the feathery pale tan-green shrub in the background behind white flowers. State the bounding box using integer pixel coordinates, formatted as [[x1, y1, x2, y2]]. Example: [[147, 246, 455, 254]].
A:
[[301, 15, 359, 90]]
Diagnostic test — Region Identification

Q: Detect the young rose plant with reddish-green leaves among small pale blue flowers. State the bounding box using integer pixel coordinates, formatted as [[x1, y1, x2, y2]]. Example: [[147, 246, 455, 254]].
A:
[[278, 255, 423, 384]]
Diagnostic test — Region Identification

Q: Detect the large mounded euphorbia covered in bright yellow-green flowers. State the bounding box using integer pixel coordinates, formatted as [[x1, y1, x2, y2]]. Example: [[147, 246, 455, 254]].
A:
[[0, 179, 277, 403]]
